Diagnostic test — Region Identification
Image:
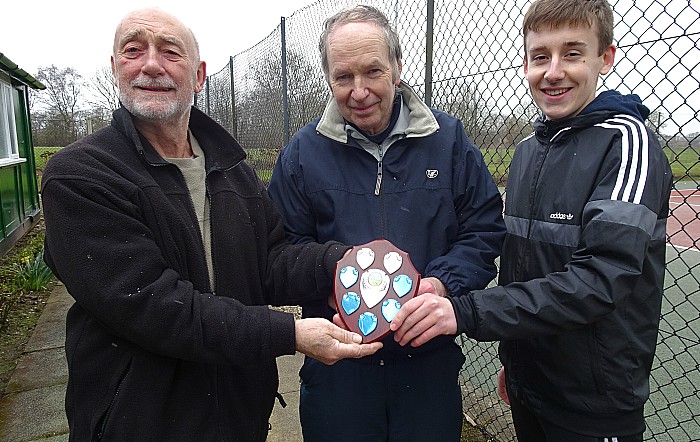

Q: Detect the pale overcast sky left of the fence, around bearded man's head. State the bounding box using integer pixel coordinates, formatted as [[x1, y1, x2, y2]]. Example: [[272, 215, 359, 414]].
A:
[[0, 0, 314, 79]]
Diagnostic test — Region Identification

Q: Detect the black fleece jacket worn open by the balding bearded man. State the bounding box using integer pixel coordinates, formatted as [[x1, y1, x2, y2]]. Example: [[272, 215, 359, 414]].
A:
[[42, 108, 347, 442]]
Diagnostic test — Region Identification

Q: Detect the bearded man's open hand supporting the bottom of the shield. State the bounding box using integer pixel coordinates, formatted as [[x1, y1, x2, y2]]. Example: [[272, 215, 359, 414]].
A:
[[294, 318, 382, 365]]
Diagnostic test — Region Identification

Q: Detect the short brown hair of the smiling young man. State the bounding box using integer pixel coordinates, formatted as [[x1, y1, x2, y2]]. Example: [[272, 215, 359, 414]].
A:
[[523, 0, 614, 56]]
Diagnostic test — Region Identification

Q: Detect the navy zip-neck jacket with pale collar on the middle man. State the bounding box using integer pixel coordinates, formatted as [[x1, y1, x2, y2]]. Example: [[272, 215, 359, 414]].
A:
[[269, 83, 505, 357]]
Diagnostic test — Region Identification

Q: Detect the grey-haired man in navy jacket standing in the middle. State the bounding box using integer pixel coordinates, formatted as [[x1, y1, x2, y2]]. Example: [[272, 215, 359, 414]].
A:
[[269, 6, 505, 442]]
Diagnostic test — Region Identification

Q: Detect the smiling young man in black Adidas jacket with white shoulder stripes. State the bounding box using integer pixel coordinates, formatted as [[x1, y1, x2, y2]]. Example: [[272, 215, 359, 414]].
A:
[[392, 0, 672, 442]]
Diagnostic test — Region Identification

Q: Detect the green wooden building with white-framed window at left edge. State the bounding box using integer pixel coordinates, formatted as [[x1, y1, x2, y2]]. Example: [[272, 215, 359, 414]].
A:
[[0, 52, 45, 256]]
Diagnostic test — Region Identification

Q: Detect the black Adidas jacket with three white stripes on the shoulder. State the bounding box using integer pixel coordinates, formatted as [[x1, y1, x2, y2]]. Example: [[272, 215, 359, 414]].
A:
[[454, 91, 672, 436]]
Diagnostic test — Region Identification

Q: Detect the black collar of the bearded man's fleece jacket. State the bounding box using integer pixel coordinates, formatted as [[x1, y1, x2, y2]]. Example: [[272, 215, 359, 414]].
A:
[[112, 106, 246, 173]]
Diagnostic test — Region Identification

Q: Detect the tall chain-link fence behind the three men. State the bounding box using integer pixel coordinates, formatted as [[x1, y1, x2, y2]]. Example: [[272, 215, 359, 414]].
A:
[[196, 0, 700, 441]]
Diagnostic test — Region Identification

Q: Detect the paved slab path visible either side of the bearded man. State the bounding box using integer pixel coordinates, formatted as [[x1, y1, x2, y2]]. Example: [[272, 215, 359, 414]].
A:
[[0, 284, 303, 442]]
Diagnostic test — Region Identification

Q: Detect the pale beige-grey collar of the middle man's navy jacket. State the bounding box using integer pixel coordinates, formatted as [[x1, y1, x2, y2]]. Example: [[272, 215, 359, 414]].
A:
[[316, 81, 440, 144]]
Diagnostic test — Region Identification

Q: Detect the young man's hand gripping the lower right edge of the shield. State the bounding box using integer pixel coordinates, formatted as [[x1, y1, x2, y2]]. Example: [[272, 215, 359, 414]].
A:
[[390, 293, 457, 347]]
